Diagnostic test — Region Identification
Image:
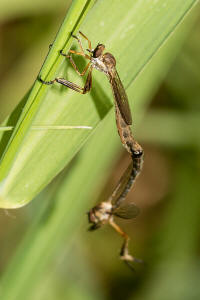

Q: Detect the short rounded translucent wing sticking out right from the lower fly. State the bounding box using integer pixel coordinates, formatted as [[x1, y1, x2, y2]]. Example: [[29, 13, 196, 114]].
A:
[[113, 203, 140, 219]]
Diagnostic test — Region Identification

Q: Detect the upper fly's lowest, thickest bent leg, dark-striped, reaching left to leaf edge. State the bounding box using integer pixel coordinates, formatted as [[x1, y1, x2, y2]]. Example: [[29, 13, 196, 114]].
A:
[[40, 68, 92, 94]]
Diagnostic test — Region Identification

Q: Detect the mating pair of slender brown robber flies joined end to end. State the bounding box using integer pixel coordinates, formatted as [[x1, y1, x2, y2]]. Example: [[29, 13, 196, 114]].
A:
[[40, 31, 143, 267]]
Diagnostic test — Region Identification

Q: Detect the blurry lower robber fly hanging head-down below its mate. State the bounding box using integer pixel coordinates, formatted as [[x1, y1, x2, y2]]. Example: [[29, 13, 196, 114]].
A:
[[88, 157, 142, 268]]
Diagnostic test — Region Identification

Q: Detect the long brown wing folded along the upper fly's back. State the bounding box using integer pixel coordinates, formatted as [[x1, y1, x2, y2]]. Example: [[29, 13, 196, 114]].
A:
[[110, 69, 132, 125]]
